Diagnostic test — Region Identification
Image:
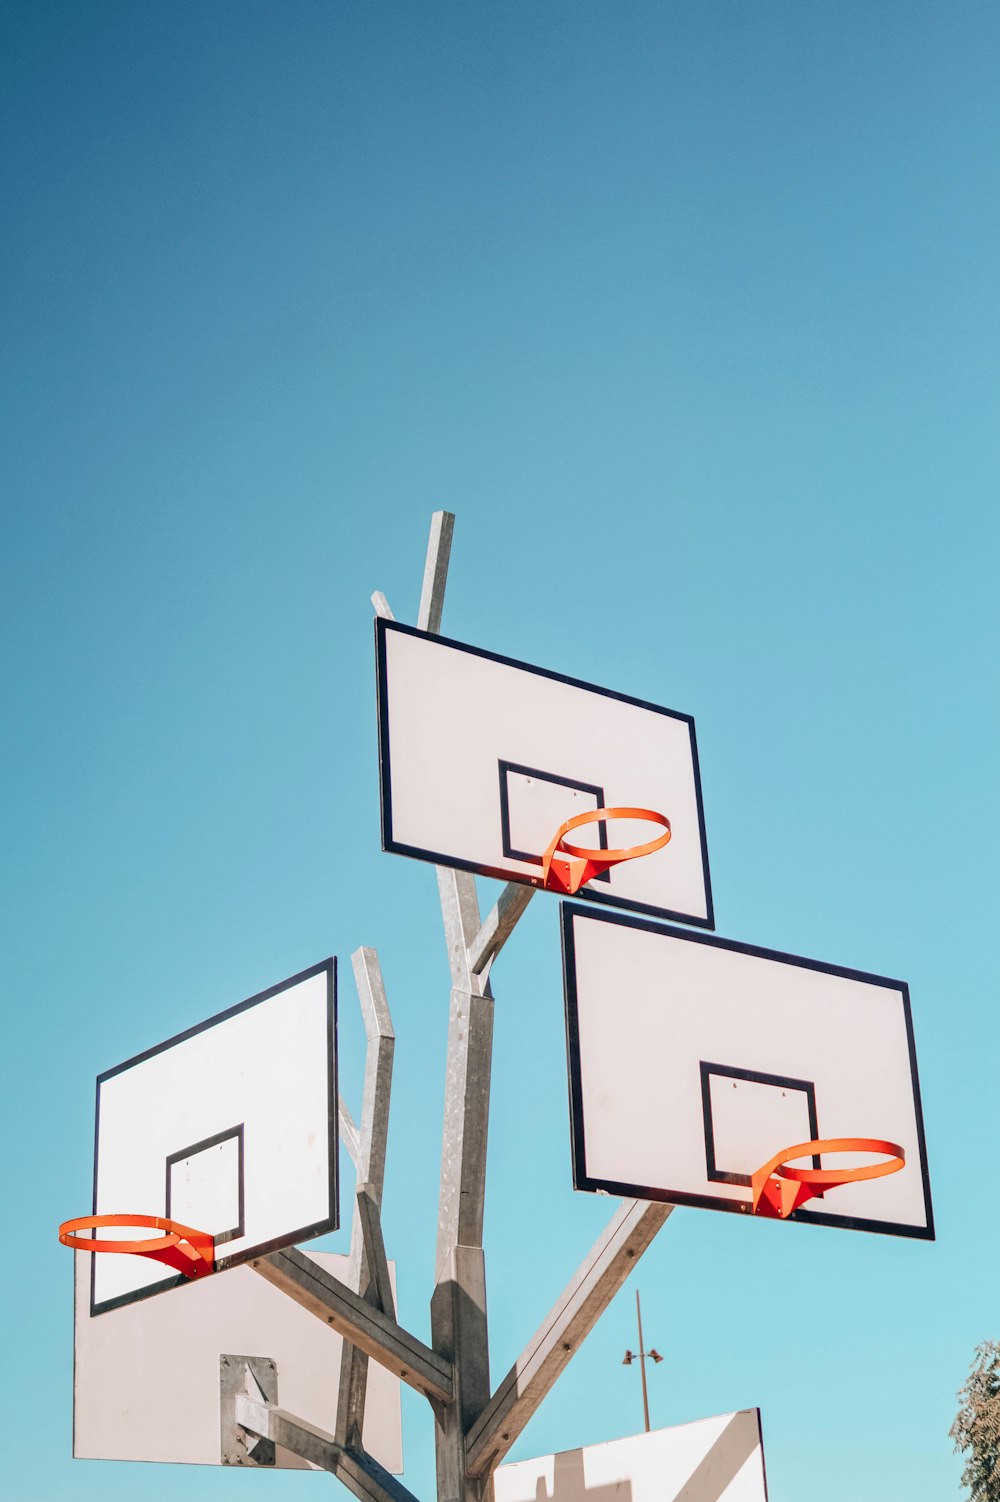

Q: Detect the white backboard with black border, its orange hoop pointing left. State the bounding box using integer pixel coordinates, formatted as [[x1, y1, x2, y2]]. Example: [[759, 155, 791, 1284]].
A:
[[92, 960, 338, 1314]]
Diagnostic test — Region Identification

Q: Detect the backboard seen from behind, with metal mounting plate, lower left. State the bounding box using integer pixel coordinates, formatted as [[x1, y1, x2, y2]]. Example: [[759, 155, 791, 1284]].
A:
[[74, 1251, 402, 1473]]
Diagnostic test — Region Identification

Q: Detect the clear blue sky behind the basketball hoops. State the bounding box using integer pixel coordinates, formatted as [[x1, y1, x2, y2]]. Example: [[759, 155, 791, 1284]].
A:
[[0, 0, 1000, 1502]]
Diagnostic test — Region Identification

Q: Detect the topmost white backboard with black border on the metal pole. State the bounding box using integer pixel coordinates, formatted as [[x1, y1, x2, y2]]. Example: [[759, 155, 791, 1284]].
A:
[[375, 619, 713, 928]]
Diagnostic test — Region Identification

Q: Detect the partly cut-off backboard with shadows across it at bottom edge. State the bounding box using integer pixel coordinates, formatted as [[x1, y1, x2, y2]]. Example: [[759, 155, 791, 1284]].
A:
[[494, 1409, 767, 1502]]
